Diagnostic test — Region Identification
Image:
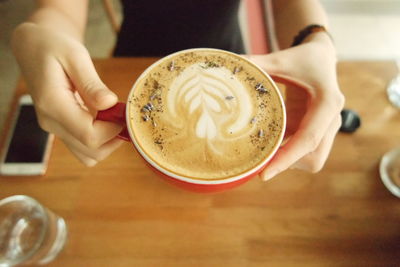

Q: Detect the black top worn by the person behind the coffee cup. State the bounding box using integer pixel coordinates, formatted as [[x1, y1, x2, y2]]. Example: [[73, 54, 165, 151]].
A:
[[114, 0, 244, 56]]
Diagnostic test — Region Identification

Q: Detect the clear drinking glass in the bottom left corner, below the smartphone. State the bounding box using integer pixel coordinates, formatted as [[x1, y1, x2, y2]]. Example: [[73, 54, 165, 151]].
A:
[[0, 195, 67, 267]]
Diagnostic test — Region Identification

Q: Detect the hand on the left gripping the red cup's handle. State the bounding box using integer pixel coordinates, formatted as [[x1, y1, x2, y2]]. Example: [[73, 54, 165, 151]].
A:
[[12, 22, 123, 166]]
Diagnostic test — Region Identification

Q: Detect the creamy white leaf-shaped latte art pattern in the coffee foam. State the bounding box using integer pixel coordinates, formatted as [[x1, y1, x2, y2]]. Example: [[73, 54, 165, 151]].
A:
[[167, 63, 253, 140]]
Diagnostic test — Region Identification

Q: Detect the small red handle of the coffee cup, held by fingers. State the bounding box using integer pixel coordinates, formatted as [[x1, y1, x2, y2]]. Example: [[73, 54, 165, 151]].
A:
[[96, 102, 131, 142]]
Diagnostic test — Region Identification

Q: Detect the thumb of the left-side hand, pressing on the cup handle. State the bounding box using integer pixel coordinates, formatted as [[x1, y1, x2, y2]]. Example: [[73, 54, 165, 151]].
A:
[[61, 48, 118, 111]]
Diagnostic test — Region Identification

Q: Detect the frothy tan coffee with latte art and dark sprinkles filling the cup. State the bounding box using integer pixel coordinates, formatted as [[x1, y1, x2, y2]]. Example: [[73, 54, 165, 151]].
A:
[[127, 49, 284, 180]]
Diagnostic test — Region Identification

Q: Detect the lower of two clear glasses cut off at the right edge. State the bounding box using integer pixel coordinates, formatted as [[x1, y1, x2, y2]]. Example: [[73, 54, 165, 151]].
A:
[[379, 147, 400, 198]]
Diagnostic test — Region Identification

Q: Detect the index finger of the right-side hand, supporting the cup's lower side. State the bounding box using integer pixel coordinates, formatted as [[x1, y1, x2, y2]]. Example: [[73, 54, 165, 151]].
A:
[[262, 91, 339, 180]]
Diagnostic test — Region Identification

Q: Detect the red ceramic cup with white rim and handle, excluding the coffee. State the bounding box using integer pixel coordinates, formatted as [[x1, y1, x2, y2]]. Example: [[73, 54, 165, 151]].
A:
[[96, 48, 286, 193]]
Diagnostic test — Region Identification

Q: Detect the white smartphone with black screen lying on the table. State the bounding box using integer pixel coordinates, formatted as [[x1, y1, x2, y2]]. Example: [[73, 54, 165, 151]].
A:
[[0, 95, 54, 176]]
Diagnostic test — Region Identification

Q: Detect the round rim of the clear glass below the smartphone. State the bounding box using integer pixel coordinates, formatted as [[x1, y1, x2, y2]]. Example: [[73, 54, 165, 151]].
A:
[[0, 195, 49, 266]]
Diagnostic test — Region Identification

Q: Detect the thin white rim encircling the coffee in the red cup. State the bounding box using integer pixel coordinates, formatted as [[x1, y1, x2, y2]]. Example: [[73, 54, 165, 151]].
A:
[[125, 48, 286, 185]]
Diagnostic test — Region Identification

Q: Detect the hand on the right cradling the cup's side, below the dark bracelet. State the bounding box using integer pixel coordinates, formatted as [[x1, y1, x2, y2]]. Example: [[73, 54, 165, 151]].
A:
[[247, 33, 344, 180]]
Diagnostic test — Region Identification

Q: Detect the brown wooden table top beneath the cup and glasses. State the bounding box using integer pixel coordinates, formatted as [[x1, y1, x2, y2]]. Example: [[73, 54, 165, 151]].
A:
[[0, 58, 400, 267]]
